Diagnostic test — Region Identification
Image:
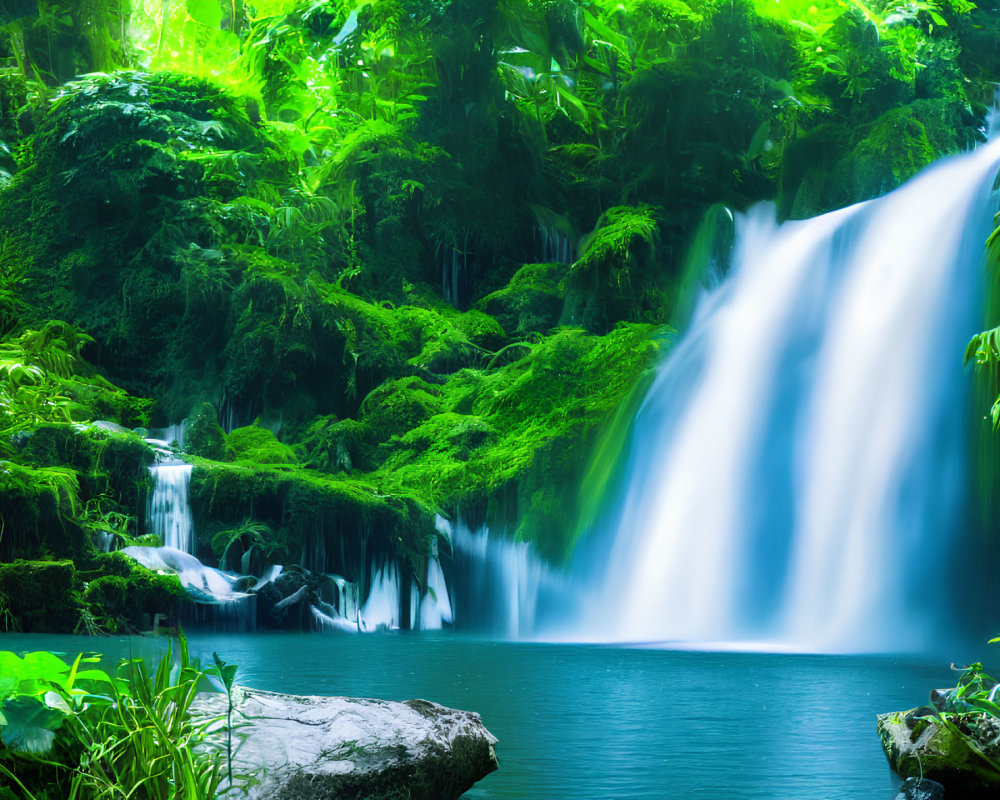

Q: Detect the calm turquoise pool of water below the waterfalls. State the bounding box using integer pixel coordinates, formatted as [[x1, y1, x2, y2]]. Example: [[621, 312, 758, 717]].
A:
[[0, 633, 968, 800]]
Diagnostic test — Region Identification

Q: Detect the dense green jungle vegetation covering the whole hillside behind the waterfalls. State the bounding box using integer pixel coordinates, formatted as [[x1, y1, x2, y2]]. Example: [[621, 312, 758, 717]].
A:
[[0, 0, 1000, 632]]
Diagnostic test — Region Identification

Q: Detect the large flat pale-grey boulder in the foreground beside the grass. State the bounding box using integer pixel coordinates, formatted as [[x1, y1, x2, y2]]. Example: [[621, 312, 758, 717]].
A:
[[195, 687, 497, 800]]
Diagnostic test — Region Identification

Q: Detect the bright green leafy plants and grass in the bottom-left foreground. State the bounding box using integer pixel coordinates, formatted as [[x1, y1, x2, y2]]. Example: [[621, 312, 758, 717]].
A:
[[0, 636, 235, 800]]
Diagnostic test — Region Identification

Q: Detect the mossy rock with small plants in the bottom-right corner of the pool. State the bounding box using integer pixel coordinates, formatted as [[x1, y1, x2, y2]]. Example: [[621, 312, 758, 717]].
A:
[[878, 707, 1000, 800]]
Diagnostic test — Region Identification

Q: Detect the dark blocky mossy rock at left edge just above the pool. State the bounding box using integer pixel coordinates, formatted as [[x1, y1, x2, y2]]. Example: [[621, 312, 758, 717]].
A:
[[0, 560, 80, 633]]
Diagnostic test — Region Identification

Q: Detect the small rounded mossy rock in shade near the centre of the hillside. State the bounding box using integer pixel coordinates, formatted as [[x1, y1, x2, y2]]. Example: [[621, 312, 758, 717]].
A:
[[476, 264, 569, 336]]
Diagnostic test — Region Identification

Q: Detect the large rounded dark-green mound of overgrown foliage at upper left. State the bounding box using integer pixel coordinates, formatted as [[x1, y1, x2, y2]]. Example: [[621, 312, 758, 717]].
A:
[[0, 73, 289, 419]]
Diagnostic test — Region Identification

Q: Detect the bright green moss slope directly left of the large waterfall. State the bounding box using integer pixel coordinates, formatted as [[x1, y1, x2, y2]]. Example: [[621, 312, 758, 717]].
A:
[[371, 325, 660, 561]]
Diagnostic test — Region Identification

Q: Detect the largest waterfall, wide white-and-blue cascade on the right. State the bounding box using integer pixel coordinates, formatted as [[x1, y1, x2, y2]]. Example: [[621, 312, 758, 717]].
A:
[[560, 139, 1000, 652]]
